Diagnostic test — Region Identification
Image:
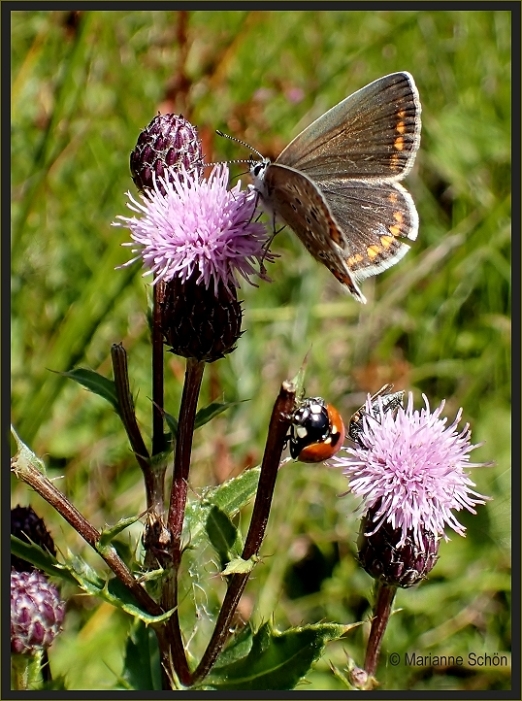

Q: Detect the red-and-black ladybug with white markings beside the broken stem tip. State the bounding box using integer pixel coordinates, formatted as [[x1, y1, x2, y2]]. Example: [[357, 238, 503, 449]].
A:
[[288, 397, 345, 462]]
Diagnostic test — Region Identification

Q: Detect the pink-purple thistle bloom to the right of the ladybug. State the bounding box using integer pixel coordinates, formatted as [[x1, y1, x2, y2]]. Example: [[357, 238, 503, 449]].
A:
[[330, 393, 490, 547]]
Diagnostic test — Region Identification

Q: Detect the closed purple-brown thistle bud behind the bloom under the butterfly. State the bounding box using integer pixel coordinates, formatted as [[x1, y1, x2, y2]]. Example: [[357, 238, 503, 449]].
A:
[[130, 114, 203, 195]]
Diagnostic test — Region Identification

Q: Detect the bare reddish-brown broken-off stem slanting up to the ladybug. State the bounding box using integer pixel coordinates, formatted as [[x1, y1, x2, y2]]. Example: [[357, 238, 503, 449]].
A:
[[193, 382, 296, 682]]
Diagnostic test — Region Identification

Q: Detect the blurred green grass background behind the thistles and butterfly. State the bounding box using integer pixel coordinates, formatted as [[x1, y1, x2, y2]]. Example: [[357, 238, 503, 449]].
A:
[[11, 10, 511, 691]]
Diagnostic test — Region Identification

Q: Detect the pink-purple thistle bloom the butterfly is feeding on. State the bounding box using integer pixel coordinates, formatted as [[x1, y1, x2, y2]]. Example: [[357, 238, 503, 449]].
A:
[[113, 164, 273, 294]]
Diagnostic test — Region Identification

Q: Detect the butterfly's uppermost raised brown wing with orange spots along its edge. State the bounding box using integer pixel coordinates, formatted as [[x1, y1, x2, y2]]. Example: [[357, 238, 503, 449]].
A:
[[276, 72, 421, 181]]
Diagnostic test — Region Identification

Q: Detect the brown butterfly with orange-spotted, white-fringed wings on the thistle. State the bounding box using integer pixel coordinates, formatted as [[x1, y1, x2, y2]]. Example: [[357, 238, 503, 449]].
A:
[[250, 72, 421, 303]]
